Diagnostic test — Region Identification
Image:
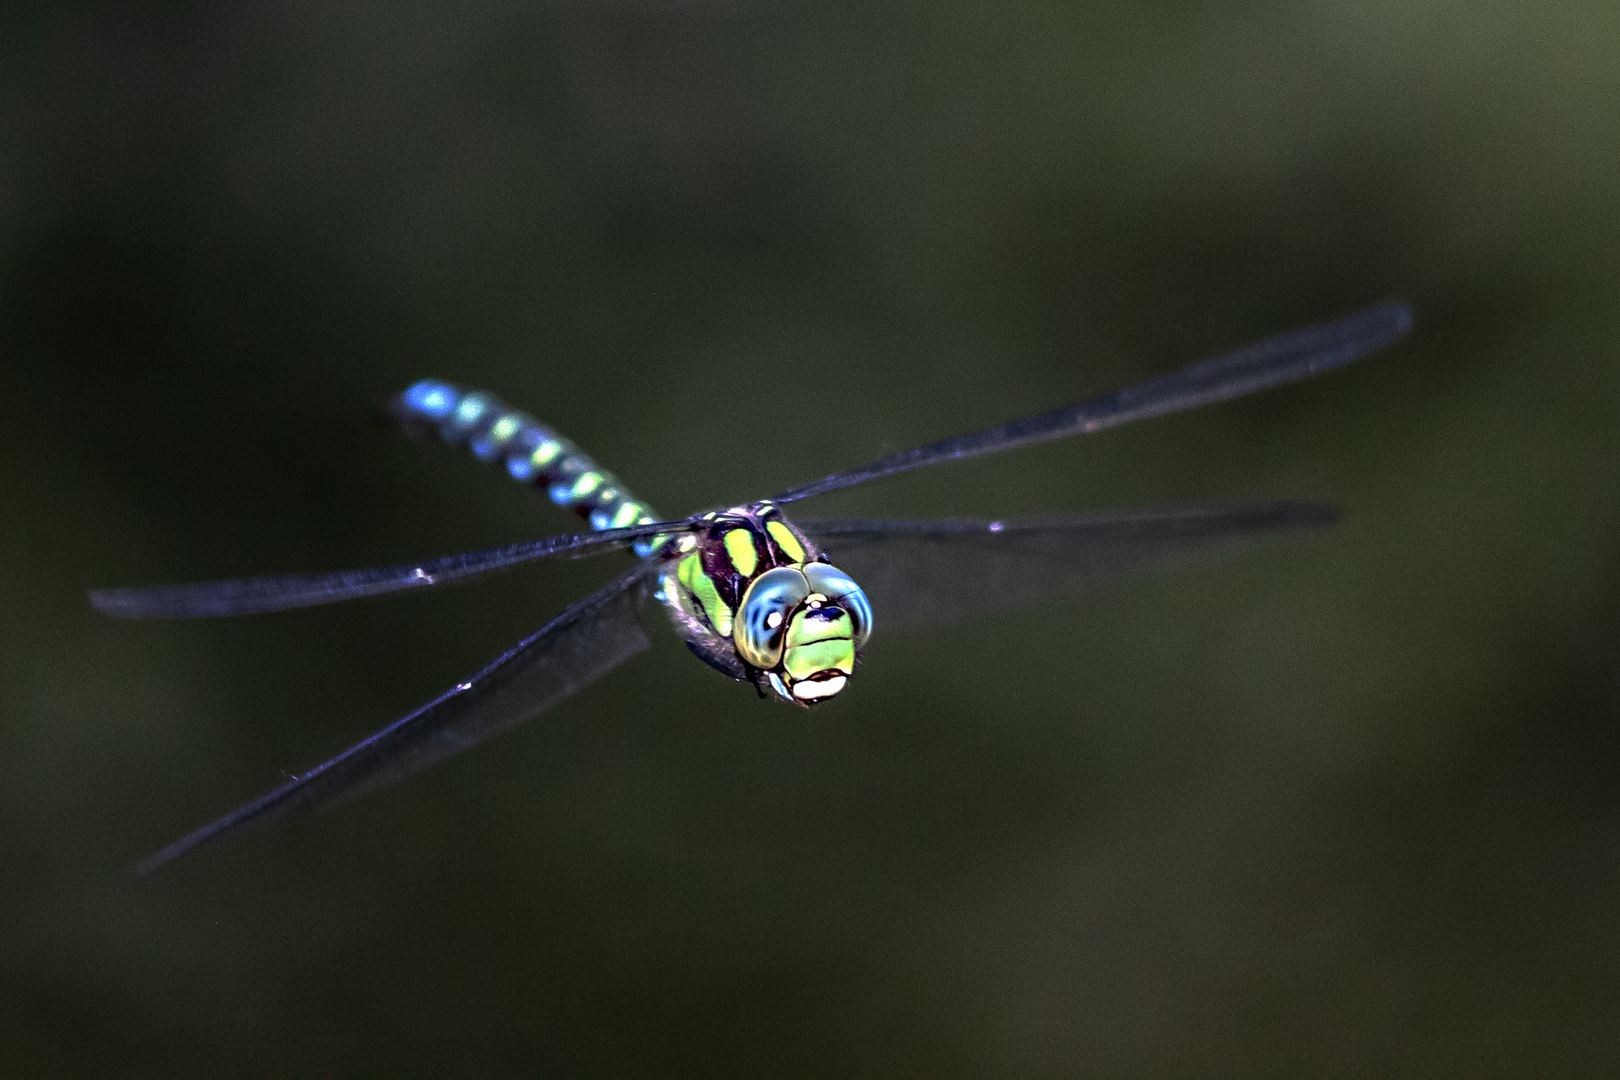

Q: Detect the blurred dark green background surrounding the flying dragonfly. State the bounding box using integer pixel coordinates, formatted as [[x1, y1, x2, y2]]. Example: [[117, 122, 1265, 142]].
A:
[[0, 0, 1620, 1078]]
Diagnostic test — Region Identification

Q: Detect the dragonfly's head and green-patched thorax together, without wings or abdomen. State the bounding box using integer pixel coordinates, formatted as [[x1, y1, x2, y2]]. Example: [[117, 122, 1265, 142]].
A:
[[658, 504, 872, 706]]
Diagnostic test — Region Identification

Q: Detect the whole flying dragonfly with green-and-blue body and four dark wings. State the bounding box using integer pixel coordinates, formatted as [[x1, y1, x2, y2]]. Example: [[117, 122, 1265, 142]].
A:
[[91, 301, 1411, 874]]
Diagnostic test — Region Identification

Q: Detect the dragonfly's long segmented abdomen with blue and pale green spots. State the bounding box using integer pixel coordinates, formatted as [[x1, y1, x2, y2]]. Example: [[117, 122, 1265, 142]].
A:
[[392, 379, 659, 555]]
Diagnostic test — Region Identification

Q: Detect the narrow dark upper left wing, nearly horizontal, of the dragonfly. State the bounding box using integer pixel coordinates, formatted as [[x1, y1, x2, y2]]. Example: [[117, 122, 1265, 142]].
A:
[[91, 521, 690, 619]]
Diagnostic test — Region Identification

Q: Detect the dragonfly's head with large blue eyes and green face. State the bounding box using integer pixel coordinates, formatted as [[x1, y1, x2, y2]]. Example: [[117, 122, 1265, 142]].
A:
[[732, 562, 872, 704]]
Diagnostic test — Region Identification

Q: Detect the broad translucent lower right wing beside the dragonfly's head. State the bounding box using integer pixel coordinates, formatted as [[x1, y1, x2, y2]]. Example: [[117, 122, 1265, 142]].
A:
[[797, 502, 1338, 635]]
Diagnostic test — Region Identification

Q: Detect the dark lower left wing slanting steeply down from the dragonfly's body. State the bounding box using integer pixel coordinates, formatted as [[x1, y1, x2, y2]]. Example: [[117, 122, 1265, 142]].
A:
[[136, 560, 658, 874]]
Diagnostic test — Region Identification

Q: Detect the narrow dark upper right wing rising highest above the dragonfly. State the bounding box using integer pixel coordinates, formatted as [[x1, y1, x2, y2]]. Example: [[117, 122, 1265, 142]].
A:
[[773, 303, 1413, 502]]
